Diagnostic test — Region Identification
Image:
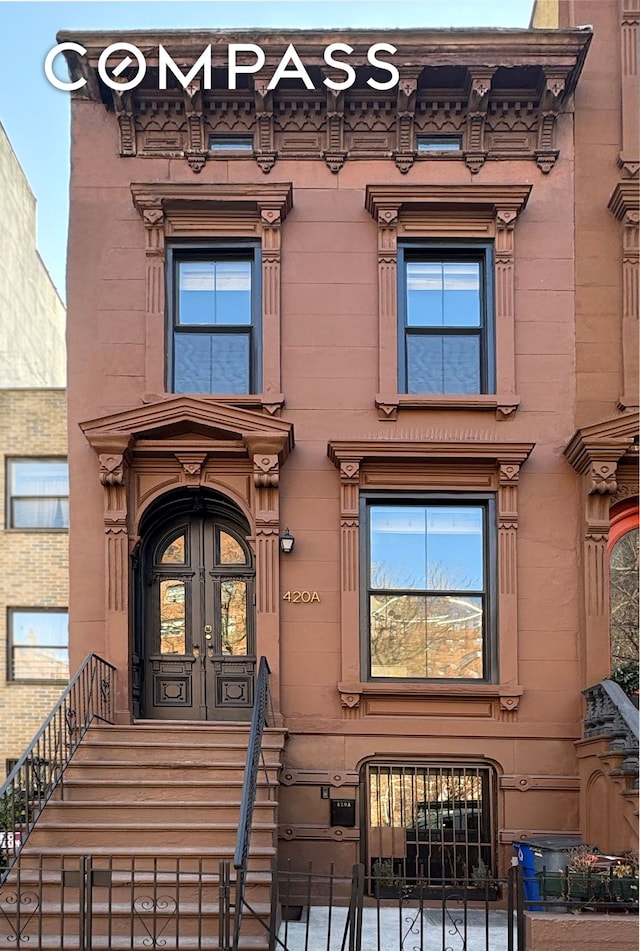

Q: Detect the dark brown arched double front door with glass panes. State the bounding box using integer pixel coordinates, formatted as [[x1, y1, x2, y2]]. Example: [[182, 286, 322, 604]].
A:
[[143, 510, 256, 720]]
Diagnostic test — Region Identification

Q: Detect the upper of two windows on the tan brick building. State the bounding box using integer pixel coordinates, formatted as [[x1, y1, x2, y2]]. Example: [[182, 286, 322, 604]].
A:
[[7, 458, 69, 531]]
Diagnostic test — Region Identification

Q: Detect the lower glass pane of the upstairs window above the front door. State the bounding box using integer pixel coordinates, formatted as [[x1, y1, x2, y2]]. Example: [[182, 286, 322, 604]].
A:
[[174, 331, 250, 393]]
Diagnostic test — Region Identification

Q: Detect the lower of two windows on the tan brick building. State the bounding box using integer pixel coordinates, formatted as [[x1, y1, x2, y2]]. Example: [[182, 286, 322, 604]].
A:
[[7, 607, 69, 682]]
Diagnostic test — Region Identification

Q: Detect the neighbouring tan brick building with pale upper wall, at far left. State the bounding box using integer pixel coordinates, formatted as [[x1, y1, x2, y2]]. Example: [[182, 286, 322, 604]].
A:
[[0, 126, 69, 767]]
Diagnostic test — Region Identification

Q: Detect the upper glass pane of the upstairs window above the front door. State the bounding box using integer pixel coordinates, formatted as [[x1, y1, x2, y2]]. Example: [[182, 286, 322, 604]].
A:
[[178, 260, 251, 326]]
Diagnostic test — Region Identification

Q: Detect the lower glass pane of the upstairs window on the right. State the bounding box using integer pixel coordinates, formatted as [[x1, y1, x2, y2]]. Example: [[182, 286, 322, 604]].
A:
[[407, 334, 480, 394]]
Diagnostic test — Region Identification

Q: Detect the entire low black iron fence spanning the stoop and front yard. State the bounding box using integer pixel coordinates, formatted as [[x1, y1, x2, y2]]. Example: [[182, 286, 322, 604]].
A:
[[0, 855, 524, 951]]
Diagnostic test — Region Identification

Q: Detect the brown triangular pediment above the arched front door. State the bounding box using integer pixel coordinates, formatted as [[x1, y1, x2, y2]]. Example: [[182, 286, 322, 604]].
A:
[[80, 396, 294, 465]]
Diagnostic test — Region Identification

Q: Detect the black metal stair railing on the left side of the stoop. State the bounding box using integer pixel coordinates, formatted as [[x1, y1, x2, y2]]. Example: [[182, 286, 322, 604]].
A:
[[0, 654, 116, 883]]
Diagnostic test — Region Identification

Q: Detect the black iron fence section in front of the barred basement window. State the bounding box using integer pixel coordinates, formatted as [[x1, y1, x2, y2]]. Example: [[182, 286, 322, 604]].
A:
[[269, 865, 524, 951]]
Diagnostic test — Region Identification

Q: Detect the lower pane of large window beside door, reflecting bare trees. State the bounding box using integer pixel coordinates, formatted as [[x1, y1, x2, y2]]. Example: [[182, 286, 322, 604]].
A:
[[370, 594, 483, 679]]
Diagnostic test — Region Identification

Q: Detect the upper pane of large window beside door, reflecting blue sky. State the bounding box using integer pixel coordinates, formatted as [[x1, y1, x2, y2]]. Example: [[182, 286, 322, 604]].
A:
[[370, 505, 484, 591]]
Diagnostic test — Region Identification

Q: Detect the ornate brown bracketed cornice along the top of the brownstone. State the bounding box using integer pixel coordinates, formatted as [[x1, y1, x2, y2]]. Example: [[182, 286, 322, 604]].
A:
[[59, 28, 591, 174]]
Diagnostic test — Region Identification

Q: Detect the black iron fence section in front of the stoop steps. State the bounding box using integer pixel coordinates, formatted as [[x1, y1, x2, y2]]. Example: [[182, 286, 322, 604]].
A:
[[0, 855, 232, 951]]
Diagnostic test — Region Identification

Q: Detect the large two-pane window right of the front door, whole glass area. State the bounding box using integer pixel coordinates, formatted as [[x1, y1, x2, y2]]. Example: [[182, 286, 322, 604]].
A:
[[366, 501, 489, 680]]
